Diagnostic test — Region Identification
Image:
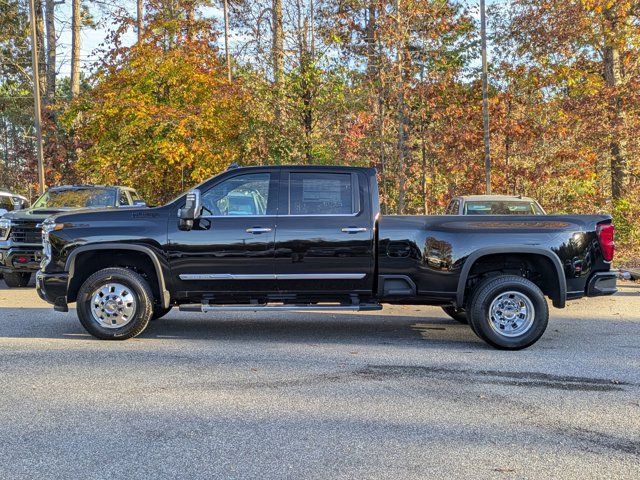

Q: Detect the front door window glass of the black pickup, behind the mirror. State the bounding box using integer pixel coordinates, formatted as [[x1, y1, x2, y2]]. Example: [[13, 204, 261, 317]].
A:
[[202, 173, 270, 216]]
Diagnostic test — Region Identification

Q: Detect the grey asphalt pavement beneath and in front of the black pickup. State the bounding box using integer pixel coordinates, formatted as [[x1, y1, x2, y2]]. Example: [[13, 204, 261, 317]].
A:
[[0, 283, 640, 480]]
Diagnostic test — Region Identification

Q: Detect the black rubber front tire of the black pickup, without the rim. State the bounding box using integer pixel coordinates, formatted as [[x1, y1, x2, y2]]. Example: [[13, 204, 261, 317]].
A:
[[76, 268, 153, 340]]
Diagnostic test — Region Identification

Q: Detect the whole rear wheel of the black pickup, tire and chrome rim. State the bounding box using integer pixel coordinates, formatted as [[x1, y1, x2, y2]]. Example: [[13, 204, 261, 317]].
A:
[[467, 275, 549, 350]]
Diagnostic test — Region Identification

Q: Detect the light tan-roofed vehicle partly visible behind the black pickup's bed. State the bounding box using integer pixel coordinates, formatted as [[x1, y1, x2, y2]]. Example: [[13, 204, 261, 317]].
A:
[[445, 195, 546, 215]]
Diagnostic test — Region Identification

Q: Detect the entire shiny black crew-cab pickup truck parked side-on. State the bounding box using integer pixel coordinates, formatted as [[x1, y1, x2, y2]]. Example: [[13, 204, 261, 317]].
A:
[[37, 166, 616, 349]]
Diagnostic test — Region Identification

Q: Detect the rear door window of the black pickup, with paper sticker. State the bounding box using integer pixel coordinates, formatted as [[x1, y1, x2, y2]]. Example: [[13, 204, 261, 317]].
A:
[[289, 172, 354, 215]]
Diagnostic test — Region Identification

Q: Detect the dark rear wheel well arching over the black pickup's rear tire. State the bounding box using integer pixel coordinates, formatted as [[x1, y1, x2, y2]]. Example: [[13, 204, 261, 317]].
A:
[[464, 253, 562, 306]]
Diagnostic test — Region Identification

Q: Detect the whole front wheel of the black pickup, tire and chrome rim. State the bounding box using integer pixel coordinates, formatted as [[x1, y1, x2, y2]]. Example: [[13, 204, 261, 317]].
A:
[[76, 268, 153, 340]]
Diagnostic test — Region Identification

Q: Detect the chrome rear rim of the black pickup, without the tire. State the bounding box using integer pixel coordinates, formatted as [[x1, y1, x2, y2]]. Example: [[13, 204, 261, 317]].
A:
[[489, 291, 536, 337]]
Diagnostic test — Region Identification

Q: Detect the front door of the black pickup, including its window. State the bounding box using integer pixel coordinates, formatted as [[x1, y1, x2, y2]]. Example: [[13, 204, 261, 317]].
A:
[[168, 172, 279, 296]]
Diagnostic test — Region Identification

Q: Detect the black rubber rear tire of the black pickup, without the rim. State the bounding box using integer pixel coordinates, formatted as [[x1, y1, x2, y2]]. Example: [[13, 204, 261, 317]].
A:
[[467, 275, 549, 350]]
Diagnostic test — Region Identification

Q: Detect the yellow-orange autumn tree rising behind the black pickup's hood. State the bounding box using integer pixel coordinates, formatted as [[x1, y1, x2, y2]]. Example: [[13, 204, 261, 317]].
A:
[[66, 0, 247, 203]]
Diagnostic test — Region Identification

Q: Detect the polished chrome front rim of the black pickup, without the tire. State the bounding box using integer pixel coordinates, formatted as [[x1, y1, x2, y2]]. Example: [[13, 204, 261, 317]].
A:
[[91, 283, 137, 328]]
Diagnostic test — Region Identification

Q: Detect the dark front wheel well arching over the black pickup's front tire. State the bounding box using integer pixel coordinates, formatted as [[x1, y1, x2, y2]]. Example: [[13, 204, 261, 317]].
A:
[[67, 250, 161, 303]]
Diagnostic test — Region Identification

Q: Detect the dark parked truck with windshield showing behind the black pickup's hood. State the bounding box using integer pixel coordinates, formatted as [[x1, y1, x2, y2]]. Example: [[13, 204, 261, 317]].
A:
[[0, 185, 144, 287]]
